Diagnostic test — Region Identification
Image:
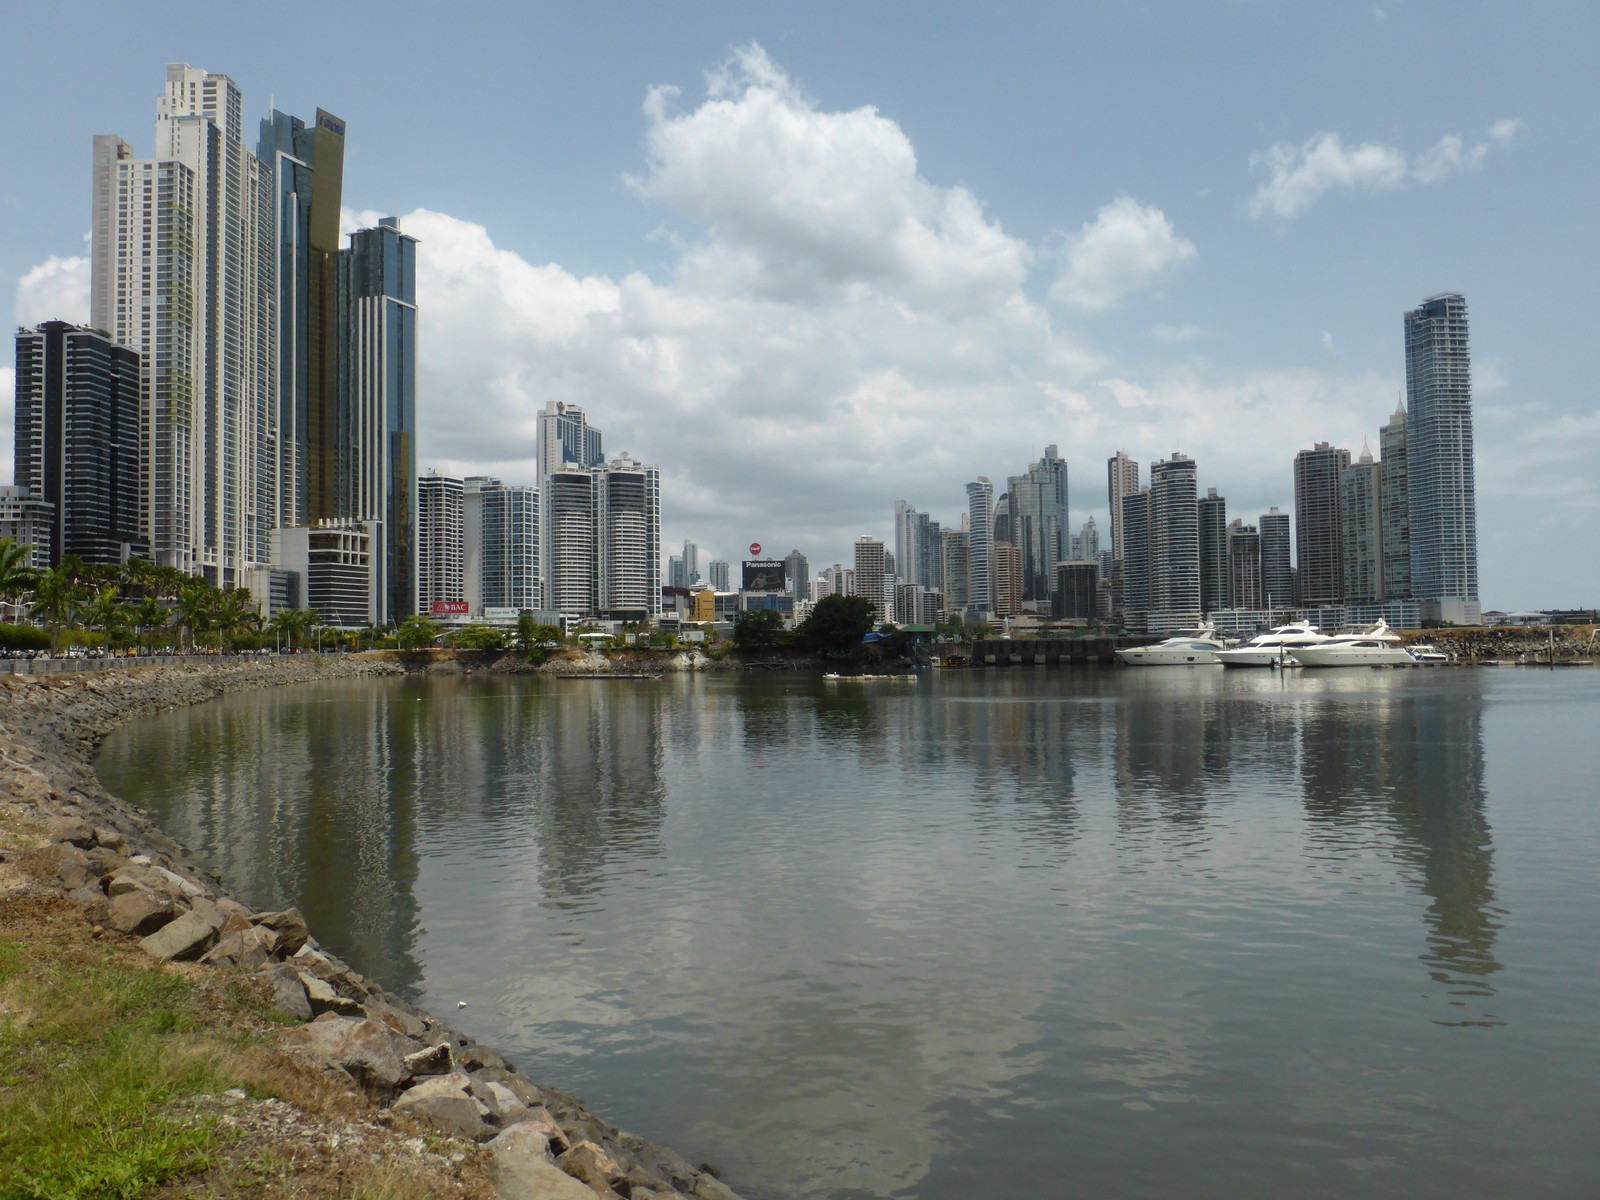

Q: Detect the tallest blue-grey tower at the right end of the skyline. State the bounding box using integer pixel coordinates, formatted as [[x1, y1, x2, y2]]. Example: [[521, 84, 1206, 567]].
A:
[[1405, 291, 1480, 622]]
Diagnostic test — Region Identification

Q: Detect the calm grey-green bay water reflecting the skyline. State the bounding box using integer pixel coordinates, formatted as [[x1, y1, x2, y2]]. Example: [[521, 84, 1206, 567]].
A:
[[101, 669, 1600, 1200]]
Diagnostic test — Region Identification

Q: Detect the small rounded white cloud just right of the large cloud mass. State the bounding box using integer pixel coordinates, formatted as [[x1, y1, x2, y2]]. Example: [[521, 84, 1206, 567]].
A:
[[1050, 195, 1197, 312]]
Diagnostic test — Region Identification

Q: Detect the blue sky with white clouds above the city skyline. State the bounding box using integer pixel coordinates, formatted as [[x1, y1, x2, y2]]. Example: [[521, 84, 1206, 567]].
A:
[[0, 0, 1600, 610]]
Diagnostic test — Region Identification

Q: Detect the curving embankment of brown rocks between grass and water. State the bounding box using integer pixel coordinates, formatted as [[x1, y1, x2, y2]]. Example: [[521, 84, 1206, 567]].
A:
[[0, 668, 738, 1200]]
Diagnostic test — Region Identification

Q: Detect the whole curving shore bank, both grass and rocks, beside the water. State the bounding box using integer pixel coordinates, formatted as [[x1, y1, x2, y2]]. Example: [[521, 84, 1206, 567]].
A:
[[0, 654, 738, 1200]]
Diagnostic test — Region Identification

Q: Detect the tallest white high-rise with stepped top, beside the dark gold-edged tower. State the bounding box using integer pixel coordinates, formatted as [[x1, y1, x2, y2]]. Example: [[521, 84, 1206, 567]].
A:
[[90, 62, 278, 587]]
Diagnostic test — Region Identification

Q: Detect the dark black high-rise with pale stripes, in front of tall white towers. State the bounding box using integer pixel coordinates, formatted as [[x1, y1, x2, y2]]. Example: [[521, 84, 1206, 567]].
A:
[[14, 322, 149, 566]]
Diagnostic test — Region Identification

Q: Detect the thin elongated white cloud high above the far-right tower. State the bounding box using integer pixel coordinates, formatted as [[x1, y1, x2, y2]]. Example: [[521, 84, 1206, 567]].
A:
[[1250, 120, 1526, 221]]
